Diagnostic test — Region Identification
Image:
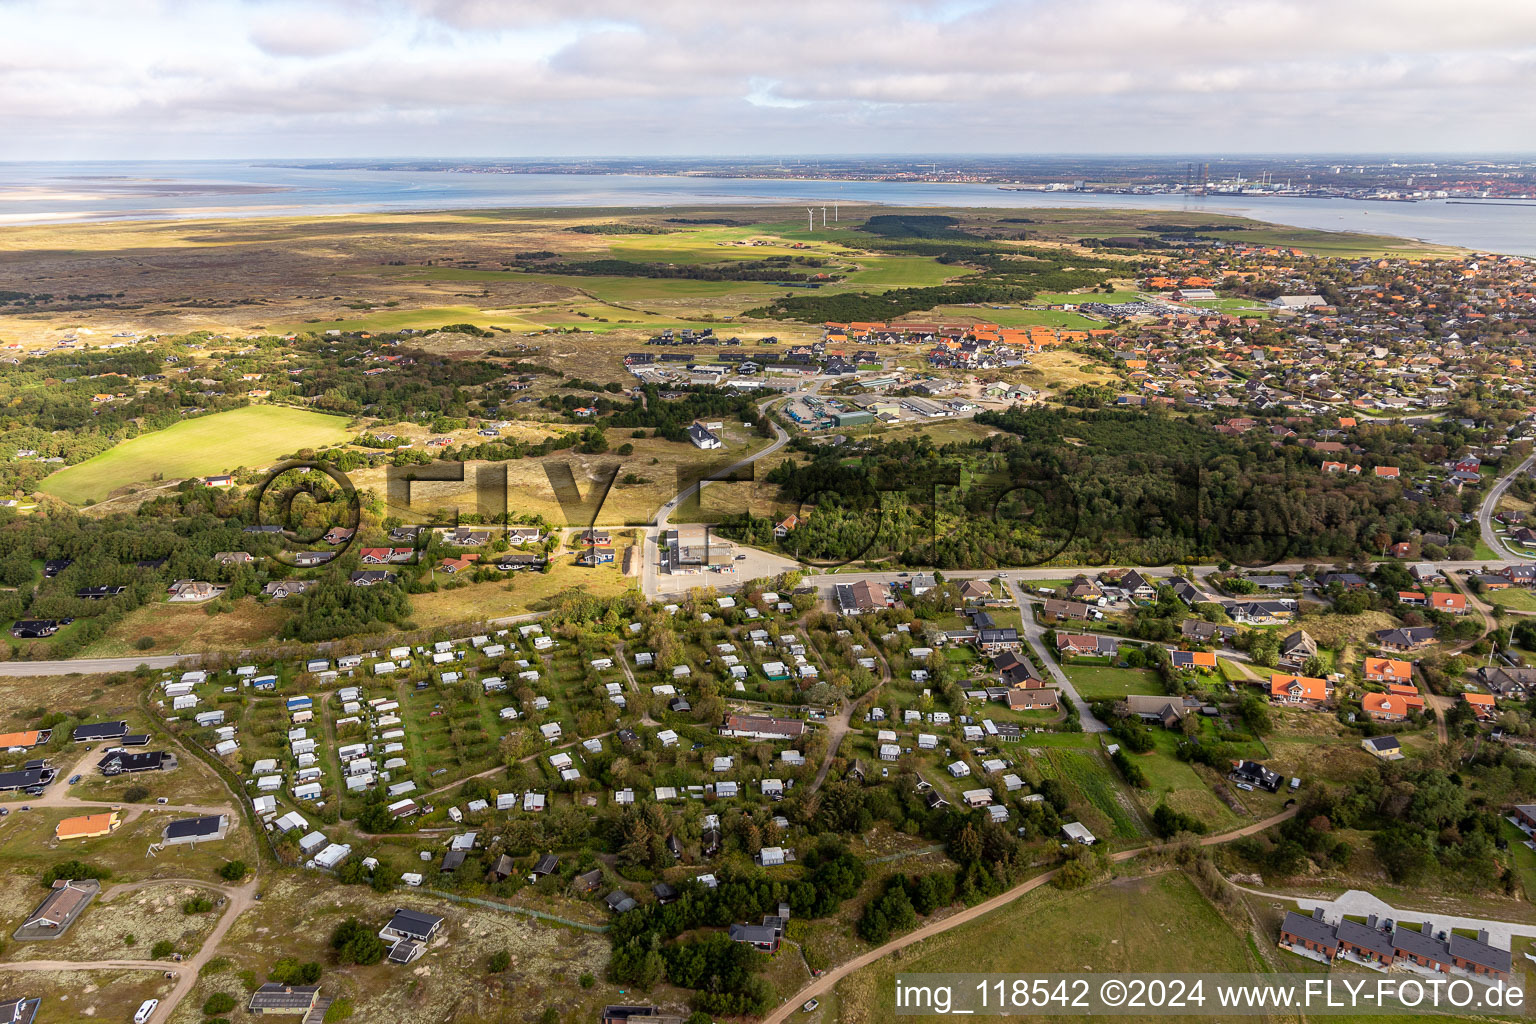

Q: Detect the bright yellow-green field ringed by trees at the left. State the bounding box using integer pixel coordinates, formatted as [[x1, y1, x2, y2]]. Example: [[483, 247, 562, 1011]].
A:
[[40, 405, 353, 504]]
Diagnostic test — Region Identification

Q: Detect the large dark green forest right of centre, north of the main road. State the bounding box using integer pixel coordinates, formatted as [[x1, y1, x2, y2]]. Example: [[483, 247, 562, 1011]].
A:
[[720, 408, 1480, 568]]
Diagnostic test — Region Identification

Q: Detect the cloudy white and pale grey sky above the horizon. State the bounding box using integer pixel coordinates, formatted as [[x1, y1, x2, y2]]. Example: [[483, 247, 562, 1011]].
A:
[[0, 0, 1536, 160]]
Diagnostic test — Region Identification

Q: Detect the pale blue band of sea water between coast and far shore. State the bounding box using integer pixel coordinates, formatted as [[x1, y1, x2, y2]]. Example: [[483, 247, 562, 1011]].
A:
[[0, 161, 1517, 256]]
